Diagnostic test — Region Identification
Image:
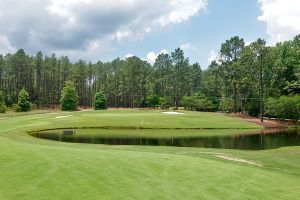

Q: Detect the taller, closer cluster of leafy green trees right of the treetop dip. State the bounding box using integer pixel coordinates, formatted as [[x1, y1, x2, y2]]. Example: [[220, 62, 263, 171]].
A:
[[201, 35, 300, 121]]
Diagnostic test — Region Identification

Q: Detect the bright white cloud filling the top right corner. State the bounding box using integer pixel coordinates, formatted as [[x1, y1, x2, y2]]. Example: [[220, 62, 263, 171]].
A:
[[258, 0, 300, 44]]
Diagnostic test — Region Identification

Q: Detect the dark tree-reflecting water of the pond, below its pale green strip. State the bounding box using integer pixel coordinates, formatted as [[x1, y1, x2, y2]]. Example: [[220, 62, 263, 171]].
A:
[[31, 129, 300, 150]]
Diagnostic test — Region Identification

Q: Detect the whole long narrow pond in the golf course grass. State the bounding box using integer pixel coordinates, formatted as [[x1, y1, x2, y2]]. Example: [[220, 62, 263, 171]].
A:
[[30, 129, 300, 150]]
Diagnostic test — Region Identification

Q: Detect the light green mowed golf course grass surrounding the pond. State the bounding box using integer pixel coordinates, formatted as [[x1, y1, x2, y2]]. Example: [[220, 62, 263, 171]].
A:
[[0, 110, 300, 200]]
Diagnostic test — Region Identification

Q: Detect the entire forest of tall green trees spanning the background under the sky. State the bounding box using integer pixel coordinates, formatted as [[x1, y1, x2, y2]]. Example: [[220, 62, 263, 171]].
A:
[[0, 35, 300, 115]]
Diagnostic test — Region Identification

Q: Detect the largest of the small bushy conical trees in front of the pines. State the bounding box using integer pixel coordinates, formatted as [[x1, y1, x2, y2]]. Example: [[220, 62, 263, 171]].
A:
[[60, 81, 78, 111]]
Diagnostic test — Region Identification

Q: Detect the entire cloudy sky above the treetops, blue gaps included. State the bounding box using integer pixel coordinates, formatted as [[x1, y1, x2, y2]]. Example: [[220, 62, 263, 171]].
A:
[[0, 0, 300, 68]]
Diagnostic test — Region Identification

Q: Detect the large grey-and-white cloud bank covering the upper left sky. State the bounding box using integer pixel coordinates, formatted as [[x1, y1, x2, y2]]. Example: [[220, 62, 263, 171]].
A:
[[0, 0, 207, 56]]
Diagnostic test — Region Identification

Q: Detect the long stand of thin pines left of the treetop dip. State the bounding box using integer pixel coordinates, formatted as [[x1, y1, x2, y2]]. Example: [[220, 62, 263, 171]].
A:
[[0, 49, 201, 108]]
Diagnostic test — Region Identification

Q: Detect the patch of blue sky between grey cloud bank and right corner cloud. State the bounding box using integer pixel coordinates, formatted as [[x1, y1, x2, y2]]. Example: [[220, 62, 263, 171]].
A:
[[113, 0, 267, 68]]
